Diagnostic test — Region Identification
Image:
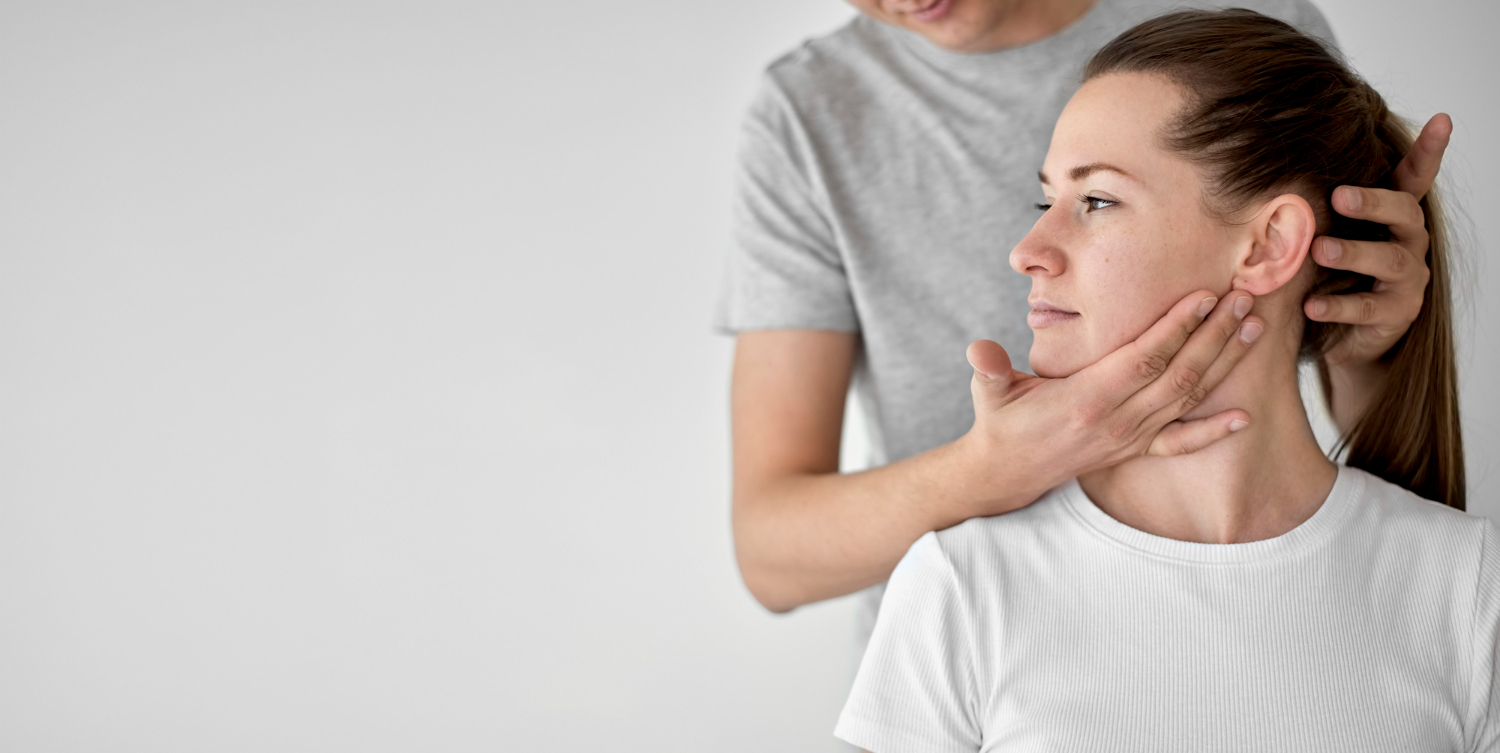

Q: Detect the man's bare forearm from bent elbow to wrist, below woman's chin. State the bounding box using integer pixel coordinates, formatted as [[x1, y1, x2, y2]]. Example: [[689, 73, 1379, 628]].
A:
[[734, 438, 1040, 612]]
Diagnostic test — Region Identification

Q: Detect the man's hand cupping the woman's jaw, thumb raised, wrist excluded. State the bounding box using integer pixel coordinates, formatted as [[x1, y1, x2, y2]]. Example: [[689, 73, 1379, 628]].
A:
[[956, 290, 1265, 516]]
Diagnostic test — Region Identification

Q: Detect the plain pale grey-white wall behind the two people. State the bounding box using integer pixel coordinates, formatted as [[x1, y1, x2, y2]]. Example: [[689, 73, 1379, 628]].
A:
[[0, 0, 1500, 752]]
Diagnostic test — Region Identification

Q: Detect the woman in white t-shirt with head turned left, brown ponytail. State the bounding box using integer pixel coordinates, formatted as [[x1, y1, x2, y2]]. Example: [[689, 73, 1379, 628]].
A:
[[836, 11, 1500, 753]]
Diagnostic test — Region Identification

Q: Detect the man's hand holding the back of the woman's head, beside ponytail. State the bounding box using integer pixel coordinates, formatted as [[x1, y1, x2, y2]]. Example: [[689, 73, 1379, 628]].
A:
[[1302, 113, 1454, 429]]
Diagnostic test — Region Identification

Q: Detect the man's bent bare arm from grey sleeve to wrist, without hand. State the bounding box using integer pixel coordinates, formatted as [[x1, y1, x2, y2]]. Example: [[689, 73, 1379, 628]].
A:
[[731, 330, 965, 612]]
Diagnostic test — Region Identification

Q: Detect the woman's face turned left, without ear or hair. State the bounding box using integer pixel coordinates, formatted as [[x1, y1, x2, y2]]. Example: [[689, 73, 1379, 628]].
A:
[[1011, 74, 1239, 377]]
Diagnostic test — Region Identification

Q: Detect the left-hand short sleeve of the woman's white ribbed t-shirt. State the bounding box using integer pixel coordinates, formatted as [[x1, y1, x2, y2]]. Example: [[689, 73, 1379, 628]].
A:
[[834, 531, 983, 753]]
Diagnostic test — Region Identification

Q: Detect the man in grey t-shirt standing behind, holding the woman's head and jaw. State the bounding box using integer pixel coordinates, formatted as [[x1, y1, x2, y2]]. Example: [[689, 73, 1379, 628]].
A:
[[714, 0, 1452, 660]]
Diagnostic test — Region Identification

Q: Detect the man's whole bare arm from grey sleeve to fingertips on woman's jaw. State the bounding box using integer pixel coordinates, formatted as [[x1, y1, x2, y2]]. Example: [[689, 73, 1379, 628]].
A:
[[731, 291, 1263, 612]]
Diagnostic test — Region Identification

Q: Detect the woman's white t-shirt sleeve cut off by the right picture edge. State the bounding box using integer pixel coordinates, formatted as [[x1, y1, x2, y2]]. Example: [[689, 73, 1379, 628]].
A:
[[1466, 521, 1500, 753]]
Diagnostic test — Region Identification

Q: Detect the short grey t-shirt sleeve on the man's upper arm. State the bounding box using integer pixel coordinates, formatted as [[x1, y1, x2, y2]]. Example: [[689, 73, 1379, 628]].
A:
[[713, 75, 860, 335]]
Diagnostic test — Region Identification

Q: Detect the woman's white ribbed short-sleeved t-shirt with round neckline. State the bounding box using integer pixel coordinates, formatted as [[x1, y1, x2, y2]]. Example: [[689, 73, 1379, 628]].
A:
[[834, 467, 1500, 753]]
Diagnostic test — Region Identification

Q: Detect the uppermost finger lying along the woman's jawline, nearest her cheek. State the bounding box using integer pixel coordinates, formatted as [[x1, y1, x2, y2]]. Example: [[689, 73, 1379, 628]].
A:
[[1074, 290, 1224, 408]]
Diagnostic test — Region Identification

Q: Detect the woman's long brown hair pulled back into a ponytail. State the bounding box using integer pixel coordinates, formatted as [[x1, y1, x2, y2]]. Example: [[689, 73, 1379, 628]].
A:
[[1083, 8, 1466, 510]]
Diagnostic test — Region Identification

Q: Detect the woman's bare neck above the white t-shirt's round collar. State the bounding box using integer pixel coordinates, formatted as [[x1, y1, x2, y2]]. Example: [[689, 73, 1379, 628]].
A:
[[1079, 333, 1338, 543]]
